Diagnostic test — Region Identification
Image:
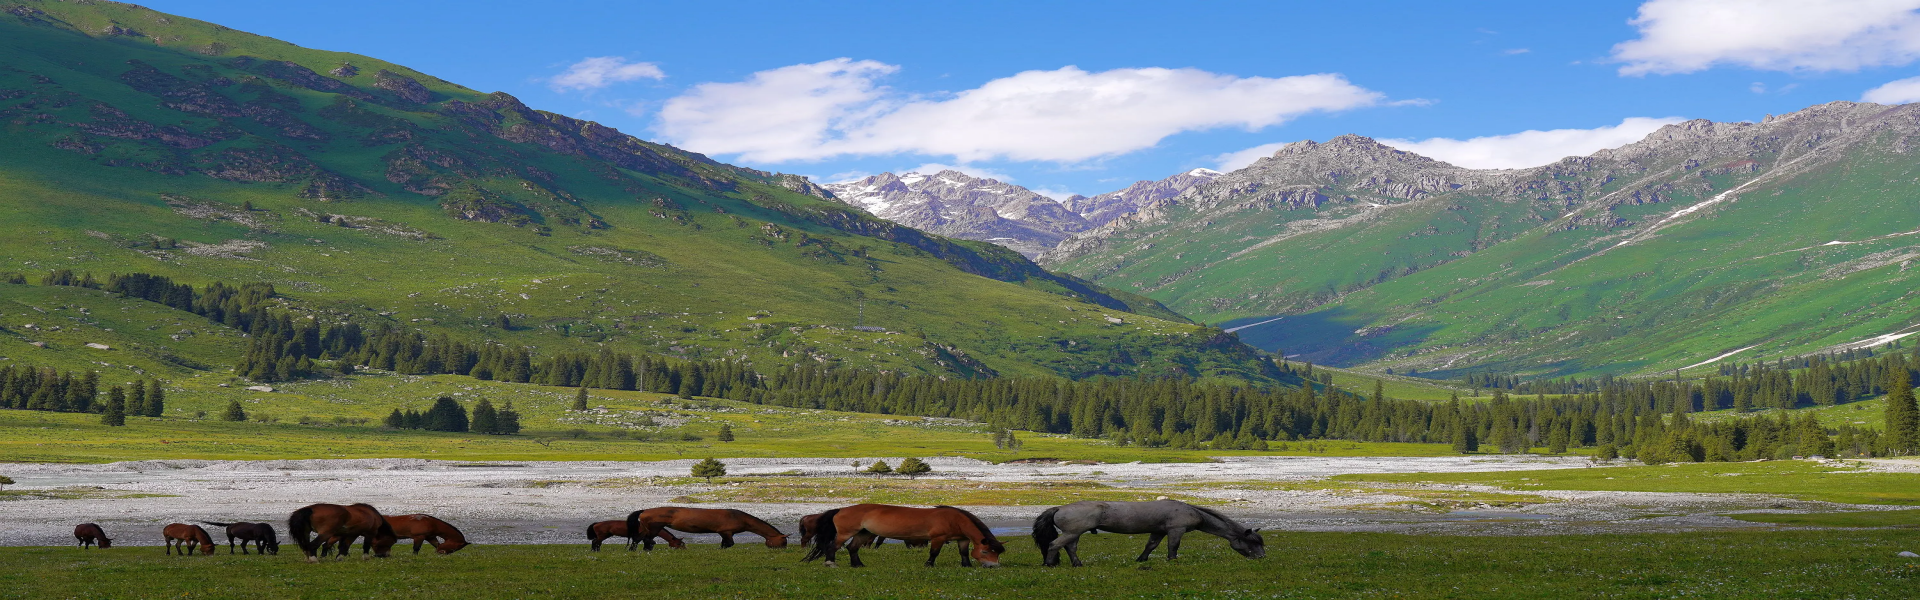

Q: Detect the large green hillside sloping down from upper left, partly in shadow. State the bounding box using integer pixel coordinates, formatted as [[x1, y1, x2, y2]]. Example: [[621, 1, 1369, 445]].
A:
[[0, 2, 1273, 379]]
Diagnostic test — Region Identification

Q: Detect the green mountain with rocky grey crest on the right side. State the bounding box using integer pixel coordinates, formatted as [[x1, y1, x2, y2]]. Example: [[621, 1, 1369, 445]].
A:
[[1043, 102, 1920, 375]]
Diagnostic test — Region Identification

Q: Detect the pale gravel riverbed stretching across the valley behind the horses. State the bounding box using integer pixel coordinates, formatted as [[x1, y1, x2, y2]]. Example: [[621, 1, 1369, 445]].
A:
[[0, 456, 1910, 546]]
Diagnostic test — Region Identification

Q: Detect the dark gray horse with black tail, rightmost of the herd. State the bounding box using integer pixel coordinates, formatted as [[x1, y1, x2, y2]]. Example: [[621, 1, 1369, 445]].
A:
[[1033, 500, 1267, 567]]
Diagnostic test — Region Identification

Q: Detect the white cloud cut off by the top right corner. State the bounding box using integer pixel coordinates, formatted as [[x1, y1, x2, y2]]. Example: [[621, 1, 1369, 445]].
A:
[[1613, 0, 1920, 75]]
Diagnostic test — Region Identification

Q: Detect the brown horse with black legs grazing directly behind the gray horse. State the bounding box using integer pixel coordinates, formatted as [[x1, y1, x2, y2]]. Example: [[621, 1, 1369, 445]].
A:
[[804, 504, 1006, 567]]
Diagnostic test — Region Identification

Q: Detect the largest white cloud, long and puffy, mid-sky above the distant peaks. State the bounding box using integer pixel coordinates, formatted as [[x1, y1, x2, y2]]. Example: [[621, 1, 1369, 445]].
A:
[[657, 58, 1382, 163]]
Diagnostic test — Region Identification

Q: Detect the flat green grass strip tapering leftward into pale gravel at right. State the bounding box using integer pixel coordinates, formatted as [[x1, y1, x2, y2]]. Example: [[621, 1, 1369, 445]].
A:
[[1334, 460, 1920, 504]]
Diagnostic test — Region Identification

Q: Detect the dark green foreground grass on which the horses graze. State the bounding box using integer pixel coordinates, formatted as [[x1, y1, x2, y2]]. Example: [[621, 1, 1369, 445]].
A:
[[0, 529, 1920, 598]]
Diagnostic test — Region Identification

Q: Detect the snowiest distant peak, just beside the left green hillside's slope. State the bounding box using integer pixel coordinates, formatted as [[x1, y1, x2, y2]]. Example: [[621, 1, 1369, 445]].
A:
[[826, 169, 1089, 256]]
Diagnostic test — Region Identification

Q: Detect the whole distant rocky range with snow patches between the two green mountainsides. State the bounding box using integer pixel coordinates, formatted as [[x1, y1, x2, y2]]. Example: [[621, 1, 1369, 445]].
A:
[[824, 169, 1219, 258]]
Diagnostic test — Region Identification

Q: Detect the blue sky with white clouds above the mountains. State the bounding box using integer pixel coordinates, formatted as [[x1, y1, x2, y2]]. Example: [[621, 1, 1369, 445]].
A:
[[146, 0, 1920, 194]]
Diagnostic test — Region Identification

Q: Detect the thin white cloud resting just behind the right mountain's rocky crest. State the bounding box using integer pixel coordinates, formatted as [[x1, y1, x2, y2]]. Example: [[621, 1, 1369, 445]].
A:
[[1380, 117, 1682, 169]]
